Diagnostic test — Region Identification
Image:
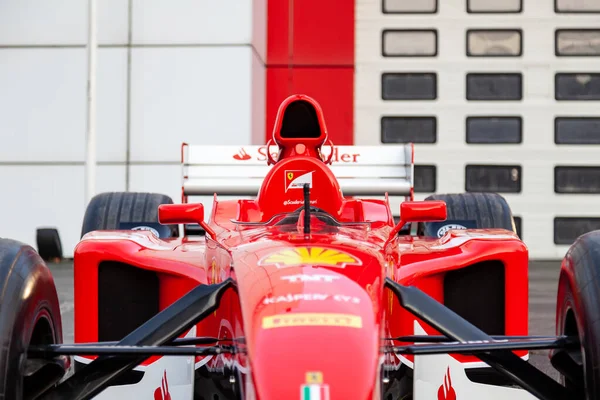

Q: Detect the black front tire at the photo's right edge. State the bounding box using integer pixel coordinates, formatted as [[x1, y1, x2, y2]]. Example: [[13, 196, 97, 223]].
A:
[[551, 231, 600, 399]]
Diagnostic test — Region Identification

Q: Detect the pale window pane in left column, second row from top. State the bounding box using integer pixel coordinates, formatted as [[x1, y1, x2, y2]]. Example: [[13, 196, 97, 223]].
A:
[[381, 29, 438, 57]]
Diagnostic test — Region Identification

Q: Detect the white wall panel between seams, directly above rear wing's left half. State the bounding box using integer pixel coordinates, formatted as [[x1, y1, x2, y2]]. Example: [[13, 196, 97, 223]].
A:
[[131, 46, 252, 162]]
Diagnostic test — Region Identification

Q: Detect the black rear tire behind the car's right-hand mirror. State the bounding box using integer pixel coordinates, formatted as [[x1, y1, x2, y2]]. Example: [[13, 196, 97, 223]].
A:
[[423, 193, 517, 237]]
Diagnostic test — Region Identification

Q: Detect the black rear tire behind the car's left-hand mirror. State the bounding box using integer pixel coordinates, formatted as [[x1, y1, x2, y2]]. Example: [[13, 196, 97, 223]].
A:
[[81, 192, 179, 238]]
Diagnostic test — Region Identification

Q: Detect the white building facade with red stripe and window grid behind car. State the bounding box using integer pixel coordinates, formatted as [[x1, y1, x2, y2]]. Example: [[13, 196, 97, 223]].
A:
[[0, 0, 600, 258]]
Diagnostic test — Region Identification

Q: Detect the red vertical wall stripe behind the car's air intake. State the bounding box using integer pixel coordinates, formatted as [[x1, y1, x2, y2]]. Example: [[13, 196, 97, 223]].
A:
[[266, 0, 354, 145]]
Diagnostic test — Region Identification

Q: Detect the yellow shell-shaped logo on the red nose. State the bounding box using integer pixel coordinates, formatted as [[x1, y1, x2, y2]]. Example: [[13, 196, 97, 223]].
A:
[[258, 247, 362, 268]]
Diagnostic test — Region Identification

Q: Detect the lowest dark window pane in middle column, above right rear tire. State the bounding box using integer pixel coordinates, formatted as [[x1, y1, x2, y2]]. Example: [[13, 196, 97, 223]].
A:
[[465, 165, 521, 193]]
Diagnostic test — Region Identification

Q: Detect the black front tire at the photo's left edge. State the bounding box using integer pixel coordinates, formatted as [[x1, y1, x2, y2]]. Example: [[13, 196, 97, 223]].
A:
[[0, 239, 69, 400]]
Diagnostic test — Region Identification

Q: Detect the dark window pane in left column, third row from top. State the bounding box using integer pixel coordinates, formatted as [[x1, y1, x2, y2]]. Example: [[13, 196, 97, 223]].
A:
[[381, 73, 437, 100]]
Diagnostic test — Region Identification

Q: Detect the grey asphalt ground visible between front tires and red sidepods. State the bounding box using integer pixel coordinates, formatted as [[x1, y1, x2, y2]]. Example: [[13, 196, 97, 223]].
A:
[[50, 261, 560, 379]]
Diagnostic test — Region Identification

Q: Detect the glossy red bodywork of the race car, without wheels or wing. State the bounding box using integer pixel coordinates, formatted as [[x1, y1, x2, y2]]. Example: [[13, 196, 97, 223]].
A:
[[74, 96, 528, 400]]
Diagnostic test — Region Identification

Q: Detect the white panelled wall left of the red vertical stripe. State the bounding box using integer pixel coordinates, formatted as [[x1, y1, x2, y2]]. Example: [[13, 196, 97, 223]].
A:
[[0, 0, 264, 256]]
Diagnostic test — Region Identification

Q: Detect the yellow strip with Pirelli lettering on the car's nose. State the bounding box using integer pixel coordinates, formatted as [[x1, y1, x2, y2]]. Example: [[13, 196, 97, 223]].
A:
[[262, 313, 362, 329]]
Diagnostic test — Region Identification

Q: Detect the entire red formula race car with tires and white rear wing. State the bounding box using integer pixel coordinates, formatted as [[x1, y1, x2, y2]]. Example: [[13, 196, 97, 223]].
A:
[[0, 95, 600, 400]]
